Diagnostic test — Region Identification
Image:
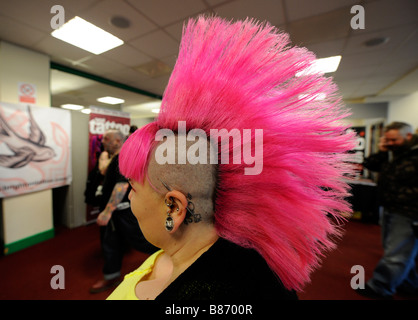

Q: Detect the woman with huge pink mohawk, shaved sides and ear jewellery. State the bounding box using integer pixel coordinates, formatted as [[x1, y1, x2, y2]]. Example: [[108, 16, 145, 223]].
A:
[[108, 17, 354, 300]]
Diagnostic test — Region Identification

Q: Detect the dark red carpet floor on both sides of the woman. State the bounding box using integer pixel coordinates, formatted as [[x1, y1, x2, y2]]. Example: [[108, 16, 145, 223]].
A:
[[0, 221, 418, 300]]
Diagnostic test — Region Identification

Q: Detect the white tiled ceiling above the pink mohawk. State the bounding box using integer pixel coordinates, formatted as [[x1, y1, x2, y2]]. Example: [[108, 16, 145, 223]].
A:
[[0, 0, 418, 116]]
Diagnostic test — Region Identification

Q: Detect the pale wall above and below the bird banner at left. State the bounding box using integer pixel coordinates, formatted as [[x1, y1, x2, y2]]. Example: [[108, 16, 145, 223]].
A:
[[0, 41, 53, 248]]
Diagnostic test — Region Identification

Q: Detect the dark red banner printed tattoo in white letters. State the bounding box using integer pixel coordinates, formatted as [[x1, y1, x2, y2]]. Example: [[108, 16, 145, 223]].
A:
[[85, 106, 131, 221]]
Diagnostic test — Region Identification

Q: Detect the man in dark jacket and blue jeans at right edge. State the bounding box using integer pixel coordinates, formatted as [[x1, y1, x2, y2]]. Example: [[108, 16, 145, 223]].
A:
[[356, 122, 418, 299]]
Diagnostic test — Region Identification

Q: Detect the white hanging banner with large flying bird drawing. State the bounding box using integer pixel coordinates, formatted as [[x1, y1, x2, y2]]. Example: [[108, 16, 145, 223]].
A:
[[0, 102, 72, 198]]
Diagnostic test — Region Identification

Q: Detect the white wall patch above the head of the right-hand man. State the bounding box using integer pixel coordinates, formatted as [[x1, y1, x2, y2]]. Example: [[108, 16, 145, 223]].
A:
[[388, 90, 418, 130]]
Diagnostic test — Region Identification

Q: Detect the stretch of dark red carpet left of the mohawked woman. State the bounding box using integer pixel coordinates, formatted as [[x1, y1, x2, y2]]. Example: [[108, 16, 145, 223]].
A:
[[0, 224, 148, 300]]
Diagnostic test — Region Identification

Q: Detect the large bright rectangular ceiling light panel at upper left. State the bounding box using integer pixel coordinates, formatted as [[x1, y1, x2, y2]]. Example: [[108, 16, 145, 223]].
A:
[[51, 17, 123, 54]]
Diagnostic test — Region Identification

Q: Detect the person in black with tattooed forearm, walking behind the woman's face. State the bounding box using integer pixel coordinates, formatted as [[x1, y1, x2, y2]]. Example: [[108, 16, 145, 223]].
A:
[[90, 130, 153, 293]]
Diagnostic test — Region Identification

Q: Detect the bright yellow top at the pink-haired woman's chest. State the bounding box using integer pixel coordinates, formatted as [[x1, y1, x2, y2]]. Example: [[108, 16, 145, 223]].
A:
[[106, 250, 164, 300]]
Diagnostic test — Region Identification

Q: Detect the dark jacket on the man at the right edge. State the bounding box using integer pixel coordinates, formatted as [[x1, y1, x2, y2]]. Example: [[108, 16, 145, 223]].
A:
[[363, 135, 418, 218]]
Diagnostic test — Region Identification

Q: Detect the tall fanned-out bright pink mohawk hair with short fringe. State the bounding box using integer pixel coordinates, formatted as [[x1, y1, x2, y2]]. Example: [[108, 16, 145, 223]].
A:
[[120, 17, 354, 291]]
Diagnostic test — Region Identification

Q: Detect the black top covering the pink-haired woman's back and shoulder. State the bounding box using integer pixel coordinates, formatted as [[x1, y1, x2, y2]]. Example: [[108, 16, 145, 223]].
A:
[[156, 238, 298, 300]]
